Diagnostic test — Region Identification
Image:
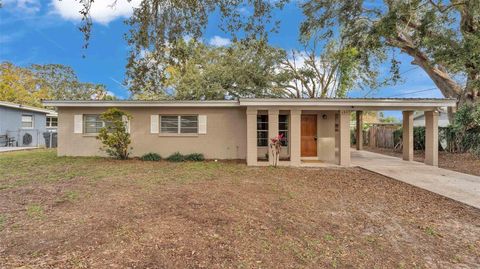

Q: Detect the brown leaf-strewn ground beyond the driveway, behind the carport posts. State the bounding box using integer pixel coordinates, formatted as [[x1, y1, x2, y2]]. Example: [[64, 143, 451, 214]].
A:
[[364, 147, 480, 176]]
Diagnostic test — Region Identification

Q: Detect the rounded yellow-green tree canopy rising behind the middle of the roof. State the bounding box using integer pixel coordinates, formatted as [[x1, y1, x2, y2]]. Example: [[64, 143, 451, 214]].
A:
[[127, 39, 284, 100]]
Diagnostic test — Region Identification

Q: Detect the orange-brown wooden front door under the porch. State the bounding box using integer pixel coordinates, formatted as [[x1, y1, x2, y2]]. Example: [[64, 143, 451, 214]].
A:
[[301, 115, 317, 157]]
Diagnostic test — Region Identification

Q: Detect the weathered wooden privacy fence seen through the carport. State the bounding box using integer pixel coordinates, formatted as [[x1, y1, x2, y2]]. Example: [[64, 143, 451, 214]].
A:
[[363, 124, 401, 149]]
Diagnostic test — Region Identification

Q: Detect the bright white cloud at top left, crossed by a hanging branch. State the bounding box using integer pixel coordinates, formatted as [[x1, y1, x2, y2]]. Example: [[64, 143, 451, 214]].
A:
[[51, 0, 141, 24]]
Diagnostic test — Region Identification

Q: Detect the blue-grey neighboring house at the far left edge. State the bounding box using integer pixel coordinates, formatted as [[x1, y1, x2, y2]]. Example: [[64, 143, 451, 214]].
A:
[[0, 101, 57, 147]]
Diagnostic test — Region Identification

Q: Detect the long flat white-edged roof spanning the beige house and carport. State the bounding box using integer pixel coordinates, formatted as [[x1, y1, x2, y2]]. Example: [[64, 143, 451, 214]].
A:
[[43, 98, 456, 110]]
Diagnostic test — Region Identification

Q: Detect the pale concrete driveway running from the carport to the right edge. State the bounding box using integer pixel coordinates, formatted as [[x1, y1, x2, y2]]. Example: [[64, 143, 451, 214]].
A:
[[352, 149, 480, 209]]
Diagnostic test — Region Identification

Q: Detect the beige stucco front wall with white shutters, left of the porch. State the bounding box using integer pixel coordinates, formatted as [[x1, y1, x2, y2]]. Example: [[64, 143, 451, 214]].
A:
[[57, 107, 247, 159]]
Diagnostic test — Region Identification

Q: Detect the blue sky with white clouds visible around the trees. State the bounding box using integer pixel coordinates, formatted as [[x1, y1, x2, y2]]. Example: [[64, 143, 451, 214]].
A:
[[0, 0, 442, 117]]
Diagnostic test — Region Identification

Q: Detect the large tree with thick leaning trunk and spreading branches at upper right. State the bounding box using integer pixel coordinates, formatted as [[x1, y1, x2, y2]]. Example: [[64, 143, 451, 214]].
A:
[[301, 0, 480, 104]]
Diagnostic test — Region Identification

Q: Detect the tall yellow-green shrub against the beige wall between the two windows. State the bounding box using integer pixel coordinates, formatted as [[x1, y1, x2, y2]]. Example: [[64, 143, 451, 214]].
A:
[[97, 108, 132, 160]]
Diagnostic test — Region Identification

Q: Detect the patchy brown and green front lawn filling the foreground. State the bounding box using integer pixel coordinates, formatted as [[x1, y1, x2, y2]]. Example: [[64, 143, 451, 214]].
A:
[[0, 150, 480, 268]]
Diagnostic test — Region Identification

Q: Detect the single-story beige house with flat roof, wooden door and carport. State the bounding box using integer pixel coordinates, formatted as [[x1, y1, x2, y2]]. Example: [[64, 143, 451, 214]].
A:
[[44, 98, 455, 166]]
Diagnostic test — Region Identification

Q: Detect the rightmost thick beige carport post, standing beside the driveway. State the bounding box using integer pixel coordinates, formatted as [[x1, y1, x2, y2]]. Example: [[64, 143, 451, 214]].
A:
[[425, 111, 438, 166]]
